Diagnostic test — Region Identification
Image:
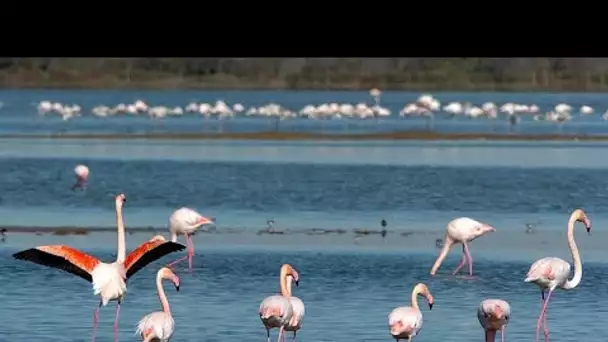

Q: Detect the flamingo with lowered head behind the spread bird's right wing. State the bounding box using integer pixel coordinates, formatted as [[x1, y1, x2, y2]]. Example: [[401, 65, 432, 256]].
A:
[[168, 208, 215, 272]]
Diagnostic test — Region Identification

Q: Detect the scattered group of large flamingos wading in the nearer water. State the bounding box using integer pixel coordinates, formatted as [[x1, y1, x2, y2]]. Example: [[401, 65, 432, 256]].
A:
[[13, 165, 591, 342]]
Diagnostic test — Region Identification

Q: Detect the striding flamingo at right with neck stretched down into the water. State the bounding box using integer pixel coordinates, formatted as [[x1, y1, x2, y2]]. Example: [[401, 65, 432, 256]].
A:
[[431, 217, 496, 277]]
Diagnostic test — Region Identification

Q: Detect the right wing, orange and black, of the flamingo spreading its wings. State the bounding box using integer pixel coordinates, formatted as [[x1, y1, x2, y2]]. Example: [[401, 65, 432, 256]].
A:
[[124, 235, 186, 279]]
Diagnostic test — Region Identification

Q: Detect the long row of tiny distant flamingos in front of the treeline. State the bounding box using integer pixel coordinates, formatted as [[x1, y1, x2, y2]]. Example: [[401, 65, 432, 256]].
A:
[[29, 89, 608, 123]]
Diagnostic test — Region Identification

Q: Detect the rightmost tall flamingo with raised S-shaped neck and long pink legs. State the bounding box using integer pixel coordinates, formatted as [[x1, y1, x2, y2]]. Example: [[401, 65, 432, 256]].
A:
[[524, 209, 591, 342]]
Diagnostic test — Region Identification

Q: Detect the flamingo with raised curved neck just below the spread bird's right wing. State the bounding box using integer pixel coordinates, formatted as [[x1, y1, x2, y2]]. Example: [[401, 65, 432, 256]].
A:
[[136, 267, 179, 342]]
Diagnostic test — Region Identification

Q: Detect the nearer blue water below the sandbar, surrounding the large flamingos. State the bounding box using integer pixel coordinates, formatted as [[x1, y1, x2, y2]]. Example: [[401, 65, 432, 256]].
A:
[[0, 92, 608, 342]]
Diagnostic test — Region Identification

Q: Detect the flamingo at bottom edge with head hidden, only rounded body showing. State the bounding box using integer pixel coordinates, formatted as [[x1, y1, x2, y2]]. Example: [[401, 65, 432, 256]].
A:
[[477, 299, 511, 342]]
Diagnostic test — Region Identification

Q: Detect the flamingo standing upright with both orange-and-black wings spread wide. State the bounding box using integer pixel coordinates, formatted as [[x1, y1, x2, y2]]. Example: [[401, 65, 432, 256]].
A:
[[13, 194, 186, 342]]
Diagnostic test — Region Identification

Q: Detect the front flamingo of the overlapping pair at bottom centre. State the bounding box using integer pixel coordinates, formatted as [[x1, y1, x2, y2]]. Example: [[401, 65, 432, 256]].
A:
[[259, 264, 304, 342]]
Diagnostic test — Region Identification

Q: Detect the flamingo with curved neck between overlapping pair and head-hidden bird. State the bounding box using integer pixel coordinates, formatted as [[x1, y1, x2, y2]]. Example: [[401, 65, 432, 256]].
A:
[[388, 283, 435, 342]]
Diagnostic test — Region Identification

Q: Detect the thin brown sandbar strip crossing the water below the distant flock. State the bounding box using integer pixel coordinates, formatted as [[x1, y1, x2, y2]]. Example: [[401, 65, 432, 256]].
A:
[[0, 131, 608, 141]]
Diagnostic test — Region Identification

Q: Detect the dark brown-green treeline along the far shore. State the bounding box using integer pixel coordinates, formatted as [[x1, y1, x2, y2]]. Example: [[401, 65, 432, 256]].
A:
[[0, 58, 608, 91]]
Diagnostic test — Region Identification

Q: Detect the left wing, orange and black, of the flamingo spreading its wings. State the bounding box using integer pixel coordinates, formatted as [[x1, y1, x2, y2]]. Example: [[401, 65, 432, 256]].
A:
[[13, 245, 100, 282]]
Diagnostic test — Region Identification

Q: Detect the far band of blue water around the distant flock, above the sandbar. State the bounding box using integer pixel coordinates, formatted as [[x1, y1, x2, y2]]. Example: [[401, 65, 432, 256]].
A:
[[0, 90, 608, 134]]
